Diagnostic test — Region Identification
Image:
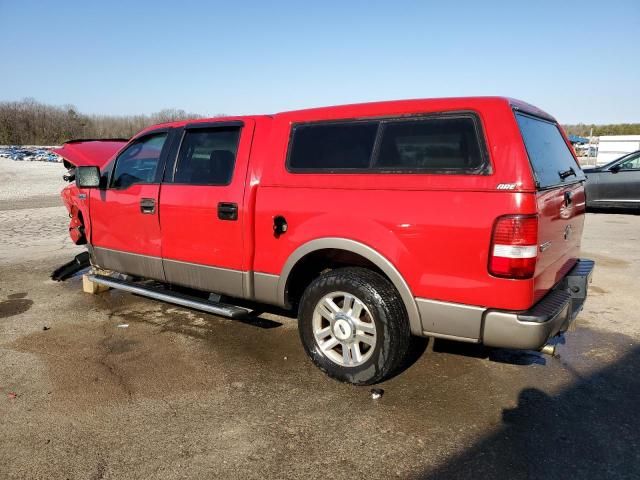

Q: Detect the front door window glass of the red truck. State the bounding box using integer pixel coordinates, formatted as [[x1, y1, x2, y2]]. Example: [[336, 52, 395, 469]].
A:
[[111, 133, 167, 188]]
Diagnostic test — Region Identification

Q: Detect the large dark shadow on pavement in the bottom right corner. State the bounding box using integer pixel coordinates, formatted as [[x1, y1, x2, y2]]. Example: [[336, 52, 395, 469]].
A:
[[417, 347, 640, 479]]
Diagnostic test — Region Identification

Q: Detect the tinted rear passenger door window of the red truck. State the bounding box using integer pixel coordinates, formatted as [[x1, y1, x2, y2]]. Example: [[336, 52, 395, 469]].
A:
[[173, 127, 240, 185]]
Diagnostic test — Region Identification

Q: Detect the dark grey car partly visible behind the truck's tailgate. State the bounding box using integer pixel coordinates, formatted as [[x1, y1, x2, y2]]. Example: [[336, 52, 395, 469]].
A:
[[584, 150, 640, 210]]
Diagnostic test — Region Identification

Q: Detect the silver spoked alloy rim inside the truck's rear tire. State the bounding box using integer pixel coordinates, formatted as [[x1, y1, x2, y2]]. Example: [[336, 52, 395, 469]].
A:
[[312, 292, 377, 367]]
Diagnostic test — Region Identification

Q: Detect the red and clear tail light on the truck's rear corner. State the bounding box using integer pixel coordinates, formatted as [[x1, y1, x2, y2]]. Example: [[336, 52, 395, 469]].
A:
[[489, 215, 538, 279]]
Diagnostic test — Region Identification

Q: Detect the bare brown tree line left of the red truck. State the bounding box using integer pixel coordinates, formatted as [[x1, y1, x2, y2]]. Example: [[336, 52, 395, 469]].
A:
[[0, 98, 202, 145]]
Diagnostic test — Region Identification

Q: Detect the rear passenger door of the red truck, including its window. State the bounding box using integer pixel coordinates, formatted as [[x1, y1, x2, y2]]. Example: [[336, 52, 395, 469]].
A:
[[160, 120, 254, 297]]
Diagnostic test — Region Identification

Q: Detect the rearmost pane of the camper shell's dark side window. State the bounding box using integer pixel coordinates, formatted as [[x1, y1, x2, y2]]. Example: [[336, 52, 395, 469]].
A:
[[374, 117, 483, 170]]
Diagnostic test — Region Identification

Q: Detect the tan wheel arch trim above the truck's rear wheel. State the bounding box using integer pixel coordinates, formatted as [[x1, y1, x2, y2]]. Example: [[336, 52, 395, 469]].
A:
[[277, 237, 422, 335]]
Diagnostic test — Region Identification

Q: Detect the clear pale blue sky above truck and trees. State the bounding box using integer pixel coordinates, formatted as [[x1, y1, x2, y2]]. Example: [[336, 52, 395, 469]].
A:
[[0, 0, 640, 123]]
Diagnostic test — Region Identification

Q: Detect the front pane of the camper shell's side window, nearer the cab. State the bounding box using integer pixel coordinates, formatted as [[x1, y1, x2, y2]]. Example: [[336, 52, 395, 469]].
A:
[[287, 122, 380, 171]]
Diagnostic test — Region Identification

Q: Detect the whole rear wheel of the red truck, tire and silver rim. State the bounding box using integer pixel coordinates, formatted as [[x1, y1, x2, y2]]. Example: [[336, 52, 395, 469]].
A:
[[298, 267, 411, 385]]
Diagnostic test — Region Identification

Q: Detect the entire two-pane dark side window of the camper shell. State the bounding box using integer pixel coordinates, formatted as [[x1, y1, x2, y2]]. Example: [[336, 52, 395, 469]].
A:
[[287, 113, 490, 174]]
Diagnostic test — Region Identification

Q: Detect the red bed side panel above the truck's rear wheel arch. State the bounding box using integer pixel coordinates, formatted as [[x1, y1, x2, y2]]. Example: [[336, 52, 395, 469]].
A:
[[255, 187, 535, 309]]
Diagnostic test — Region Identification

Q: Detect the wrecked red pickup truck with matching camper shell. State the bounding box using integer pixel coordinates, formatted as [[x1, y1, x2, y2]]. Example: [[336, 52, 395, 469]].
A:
[[58, 97, 594, 384]]
